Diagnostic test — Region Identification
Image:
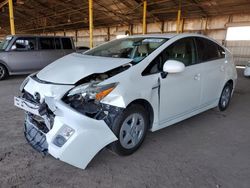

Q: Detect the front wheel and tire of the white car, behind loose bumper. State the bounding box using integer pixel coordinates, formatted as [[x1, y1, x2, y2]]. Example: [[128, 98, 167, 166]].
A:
[[110, 105, 149, 155]]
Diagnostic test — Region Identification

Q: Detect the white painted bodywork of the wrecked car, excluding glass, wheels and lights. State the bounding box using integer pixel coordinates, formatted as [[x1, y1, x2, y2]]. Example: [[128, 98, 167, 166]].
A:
[[14, 34, 237, 169]]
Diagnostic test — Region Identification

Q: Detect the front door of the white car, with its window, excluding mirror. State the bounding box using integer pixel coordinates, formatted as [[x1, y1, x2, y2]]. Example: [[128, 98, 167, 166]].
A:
[[159, 37, 202, 126]]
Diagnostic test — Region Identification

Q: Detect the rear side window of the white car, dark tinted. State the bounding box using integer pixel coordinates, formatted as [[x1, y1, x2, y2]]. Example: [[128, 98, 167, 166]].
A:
[[196, 37, 225, 62]]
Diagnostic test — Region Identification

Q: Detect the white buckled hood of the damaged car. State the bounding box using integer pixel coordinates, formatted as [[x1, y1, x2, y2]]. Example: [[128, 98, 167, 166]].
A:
[[37, 53, 132, 84]]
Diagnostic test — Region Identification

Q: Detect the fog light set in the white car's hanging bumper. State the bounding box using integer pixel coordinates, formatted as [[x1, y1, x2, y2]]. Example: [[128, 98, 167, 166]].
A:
[[53, 126, 75, 147]]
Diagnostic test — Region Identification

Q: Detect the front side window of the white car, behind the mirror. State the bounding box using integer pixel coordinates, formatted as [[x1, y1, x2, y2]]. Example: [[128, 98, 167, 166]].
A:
[[142, 37, 196, 76]]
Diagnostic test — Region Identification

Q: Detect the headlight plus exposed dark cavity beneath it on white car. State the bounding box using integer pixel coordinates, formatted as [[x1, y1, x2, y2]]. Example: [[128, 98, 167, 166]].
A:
[[62, 82, 123, 128]]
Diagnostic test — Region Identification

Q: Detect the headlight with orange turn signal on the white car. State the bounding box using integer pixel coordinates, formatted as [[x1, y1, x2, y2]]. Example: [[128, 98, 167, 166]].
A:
[[68, 82, 118, 101]]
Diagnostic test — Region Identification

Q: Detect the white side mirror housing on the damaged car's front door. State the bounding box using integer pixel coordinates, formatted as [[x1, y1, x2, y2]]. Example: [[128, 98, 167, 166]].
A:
[[163, 60, 185, 73]]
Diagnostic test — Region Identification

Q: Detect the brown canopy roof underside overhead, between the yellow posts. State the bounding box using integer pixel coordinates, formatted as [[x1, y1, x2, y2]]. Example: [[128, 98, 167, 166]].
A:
[[0, 0, 250, 34]]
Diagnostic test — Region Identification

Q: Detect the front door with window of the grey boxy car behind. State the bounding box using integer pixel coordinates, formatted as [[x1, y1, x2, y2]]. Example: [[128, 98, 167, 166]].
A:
[[7, 37, 42, 73]]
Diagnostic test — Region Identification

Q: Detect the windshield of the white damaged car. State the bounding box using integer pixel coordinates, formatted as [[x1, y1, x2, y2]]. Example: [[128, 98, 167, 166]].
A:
[[84, 37, 168, 63]]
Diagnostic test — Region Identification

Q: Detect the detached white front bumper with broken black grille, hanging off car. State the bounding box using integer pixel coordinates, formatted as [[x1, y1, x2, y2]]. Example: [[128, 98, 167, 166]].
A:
[[14, 91, 117, 169]]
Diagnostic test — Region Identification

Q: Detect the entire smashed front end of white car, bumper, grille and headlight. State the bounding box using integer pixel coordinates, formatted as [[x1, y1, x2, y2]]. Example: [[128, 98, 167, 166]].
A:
[[14, 69, 127, 169]]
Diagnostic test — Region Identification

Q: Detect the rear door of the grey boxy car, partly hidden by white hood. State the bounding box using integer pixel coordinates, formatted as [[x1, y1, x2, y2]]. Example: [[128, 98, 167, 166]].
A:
[[39, 37, 64, 68]]
